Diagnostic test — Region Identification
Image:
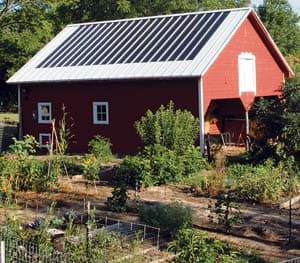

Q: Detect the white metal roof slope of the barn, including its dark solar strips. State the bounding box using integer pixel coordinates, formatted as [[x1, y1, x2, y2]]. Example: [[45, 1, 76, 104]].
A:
[[8, 8, 252, 83]]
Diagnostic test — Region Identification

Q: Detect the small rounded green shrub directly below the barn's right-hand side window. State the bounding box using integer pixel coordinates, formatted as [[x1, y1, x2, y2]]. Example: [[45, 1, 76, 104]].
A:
[[89, 135, 113, 162]]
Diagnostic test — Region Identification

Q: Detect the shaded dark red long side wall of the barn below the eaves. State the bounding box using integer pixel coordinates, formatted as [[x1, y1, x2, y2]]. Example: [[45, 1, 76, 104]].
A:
[[21, 79, 198, 154]]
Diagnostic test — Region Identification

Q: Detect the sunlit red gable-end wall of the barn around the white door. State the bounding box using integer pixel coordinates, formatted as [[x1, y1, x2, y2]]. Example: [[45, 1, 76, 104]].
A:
[[203, 17, 284, 111]]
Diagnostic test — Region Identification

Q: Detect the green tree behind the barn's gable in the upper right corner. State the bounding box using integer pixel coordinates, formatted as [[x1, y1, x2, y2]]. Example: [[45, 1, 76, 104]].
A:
[[257, 0, 300, 55]]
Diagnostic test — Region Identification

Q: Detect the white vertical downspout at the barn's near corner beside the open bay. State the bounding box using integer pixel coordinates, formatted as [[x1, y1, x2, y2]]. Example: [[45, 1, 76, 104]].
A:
[[197, 76, 205, 154]]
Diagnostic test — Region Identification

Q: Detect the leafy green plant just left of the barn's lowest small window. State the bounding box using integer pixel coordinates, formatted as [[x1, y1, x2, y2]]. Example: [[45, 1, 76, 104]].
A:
[[9, 135, 38, 159]]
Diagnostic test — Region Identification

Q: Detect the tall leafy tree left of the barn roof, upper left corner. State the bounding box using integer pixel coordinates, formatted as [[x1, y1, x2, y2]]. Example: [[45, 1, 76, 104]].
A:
[[0, 0, 53, 110]]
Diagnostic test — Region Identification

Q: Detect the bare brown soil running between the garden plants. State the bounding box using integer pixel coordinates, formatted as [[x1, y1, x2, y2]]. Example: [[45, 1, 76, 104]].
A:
[[0, 176, 300, 262]]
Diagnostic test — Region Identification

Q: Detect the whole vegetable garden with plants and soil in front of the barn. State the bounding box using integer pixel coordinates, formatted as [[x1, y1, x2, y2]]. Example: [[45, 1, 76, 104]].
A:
[[0, 96, 300, 262]]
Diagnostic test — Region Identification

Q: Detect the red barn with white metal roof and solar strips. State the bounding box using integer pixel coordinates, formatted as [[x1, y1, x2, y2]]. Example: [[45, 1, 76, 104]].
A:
[[8, 8, 293, 154]]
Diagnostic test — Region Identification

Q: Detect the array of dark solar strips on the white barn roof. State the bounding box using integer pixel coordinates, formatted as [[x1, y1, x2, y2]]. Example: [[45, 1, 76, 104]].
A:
[[37, 11, 229, 68]]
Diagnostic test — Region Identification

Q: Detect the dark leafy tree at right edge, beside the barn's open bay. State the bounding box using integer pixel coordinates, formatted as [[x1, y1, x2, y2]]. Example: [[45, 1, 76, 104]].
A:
[[253, 78, 300, 160]]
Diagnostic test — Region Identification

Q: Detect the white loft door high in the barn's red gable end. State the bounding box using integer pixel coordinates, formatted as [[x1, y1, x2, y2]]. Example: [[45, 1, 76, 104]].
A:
[[238, 52, 256, 95]]
